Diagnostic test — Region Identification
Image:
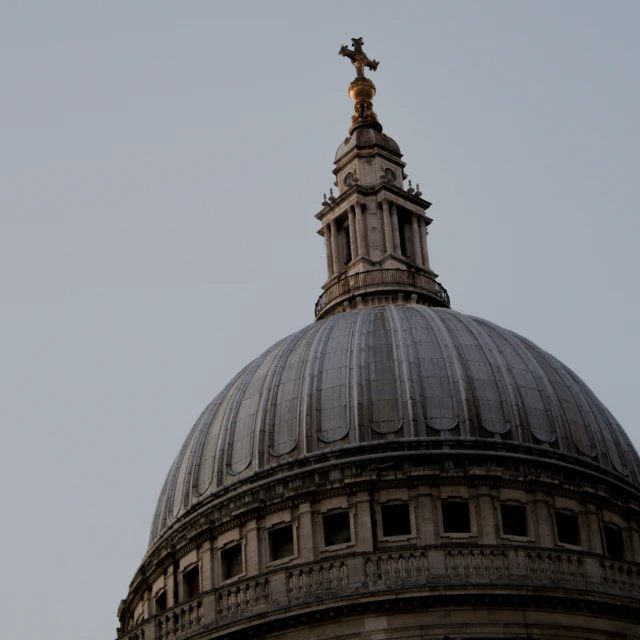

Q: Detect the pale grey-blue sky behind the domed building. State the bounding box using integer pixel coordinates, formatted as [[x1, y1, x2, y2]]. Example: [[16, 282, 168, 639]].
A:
[[0, 0, 640, 640]]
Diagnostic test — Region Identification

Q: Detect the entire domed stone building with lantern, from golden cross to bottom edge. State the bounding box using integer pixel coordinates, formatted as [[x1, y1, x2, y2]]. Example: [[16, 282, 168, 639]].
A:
[[118, 39, 640, 640]]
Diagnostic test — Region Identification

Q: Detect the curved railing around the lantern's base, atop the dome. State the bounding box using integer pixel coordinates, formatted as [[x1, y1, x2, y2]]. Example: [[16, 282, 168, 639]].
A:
[[316, 269, 450, 316]]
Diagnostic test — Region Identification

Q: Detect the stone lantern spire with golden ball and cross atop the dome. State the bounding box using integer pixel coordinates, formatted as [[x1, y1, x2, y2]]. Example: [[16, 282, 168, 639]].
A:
[[315, 38, 449, 319]]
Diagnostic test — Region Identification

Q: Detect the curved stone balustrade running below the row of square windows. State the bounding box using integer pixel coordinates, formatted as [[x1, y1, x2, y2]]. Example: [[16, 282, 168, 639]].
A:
[[118, 544, 640, 640]]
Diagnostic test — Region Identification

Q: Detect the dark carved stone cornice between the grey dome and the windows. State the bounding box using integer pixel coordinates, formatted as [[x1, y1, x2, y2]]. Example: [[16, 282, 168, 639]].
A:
[[124, 440, 640, 595]]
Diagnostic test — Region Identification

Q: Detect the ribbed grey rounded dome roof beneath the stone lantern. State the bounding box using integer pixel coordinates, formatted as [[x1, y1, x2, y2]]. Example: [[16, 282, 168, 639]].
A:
[[150, 305, 640, 543]]
